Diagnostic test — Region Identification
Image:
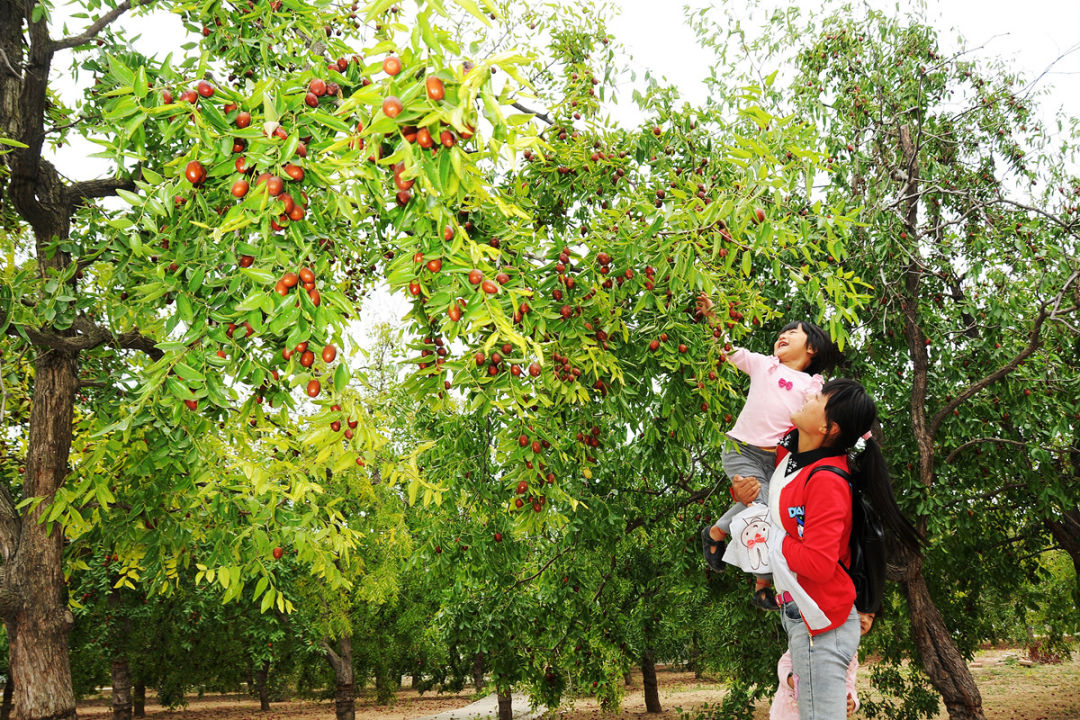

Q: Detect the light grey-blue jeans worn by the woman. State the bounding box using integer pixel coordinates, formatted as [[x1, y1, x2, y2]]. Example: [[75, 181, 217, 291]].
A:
[[780, 602, 859, 720]]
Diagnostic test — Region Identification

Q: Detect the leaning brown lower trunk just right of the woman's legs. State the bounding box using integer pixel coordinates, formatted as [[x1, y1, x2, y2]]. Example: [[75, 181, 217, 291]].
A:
[[902, 560, 986, 720]]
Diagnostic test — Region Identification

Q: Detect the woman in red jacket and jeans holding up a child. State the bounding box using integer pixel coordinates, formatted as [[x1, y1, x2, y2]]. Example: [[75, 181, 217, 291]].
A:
[[769, 379, 919, 720]]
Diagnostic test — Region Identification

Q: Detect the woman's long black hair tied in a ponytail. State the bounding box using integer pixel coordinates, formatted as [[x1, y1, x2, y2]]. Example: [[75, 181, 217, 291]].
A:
[[821, 378, 922, 554]]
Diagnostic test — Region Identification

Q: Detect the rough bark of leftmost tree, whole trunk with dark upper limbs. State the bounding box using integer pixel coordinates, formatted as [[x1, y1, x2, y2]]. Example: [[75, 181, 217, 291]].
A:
[[0, 0, 141, 720]]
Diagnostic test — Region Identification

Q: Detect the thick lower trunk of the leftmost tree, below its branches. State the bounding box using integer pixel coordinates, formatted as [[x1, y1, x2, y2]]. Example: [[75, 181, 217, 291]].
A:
[[0, 349, 78, 720]]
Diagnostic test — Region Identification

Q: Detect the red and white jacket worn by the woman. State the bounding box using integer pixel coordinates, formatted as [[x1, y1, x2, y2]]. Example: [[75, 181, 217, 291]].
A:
[[769, 429, 855, 636]]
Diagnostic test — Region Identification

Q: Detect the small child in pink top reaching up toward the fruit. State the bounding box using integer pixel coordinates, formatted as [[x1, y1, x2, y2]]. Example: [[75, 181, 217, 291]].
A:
[[698, 295, 839, 610]]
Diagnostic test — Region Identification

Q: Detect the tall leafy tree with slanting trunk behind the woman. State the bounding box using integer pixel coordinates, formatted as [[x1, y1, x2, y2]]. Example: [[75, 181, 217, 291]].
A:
[[682, 3, 1080, 718]]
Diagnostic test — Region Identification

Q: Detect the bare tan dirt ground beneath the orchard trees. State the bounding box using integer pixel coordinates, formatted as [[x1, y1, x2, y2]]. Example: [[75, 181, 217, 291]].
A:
[[79, 649, 1080, 720]]
